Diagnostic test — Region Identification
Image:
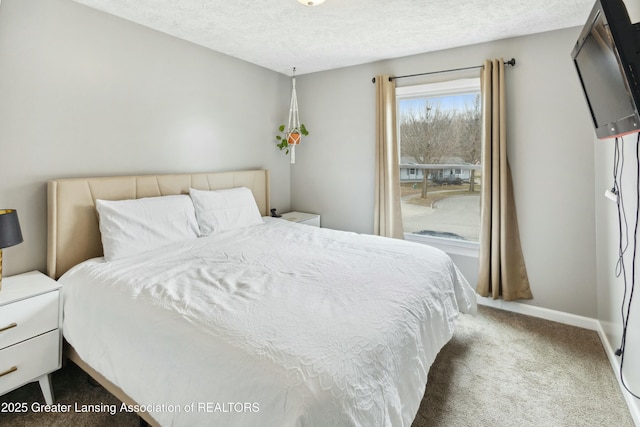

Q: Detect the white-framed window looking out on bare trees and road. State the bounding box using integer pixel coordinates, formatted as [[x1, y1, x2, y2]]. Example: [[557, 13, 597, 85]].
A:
[[396, 78, 482, 247]]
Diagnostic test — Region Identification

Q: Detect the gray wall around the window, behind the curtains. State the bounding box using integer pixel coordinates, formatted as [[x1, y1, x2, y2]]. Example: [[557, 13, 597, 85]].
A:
[[291, 28, 596, 317]]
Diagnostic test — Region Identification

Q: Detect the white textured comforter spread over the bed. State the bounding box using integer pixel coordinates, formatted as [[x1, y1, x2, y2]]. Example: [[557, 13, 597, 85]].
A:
[[60, 218, 476, 427]]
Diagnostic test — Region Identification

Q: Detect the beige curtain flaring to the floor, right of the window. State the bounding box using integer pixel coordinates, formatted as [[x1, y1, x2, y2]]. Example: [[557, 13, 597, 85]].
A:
[[477, 58, 533, 301]]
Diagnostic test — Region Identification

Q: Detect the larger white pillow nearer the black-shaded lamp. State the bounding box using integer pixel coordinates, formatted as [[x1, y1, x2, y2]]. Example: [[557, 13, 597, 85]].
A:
[[96, 194, 198, 261]]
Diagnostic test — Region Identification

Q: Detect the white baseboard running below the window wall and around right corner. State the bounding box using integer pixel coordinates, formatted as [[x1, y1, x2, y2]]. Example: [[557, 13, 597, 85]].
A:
[[476, 295, 640, 427]]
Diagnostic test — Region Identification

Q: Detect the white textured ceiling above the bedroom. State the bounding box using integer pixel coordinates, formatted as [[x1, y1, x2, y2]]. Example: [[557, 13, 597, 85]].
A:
[[74, 0, 594, 75]]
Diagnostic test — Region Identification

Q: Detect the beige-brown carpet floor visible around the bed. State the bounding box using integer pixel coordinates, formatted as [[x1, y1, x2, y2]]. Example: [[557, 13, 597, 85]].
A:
[[0, 307, 633, 427]]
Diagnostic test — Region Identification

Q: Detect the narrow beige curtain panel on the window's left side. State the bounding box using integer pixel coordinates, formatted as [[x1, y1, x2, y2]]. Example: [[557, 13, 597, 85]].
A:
[[373, 75, 403, 239]]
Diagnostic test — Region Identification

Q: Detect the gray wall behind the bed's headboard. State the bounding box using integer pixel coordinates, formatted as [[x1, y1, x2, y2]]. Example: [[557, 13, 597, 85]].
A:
[[0, 0, 290, 275]]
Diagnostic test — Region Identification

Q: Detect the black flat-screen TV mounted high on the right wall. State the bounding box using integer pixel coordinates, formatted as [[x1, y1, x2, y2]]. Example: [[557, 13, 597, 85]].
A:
[[571, 0, 640, 139]]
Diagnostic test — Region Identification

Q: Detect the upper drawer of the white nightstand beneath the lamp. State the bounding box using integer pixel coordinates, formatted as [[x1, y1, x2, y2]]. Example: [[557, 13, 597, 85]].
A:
[[0, 290, 60, 349]]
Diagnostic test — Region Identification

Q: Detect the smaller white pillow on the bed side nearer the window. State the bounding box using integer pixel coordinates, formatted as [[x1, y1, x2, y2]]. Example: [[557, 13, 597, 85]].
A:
[[189, 187, 262, 236]]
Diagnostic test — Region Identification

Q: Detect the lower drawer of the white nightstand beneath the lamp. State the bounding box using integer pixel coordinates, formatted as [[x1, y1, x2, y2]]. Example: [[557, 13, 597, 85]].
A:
[[0, 329, 60, 393]]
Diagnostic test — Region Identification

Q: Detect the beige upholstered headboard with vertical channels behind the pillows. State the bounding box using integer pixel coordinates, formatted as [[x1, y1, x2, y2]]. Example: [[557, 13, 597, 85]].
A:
[[47, 170, 269, 279]]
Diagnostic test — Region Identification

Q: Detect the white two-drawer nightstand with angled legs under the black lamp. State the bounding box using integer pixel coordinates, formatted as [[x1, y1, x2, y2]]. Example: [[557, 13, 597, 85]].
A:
[[0, 271, 62, 405]]
